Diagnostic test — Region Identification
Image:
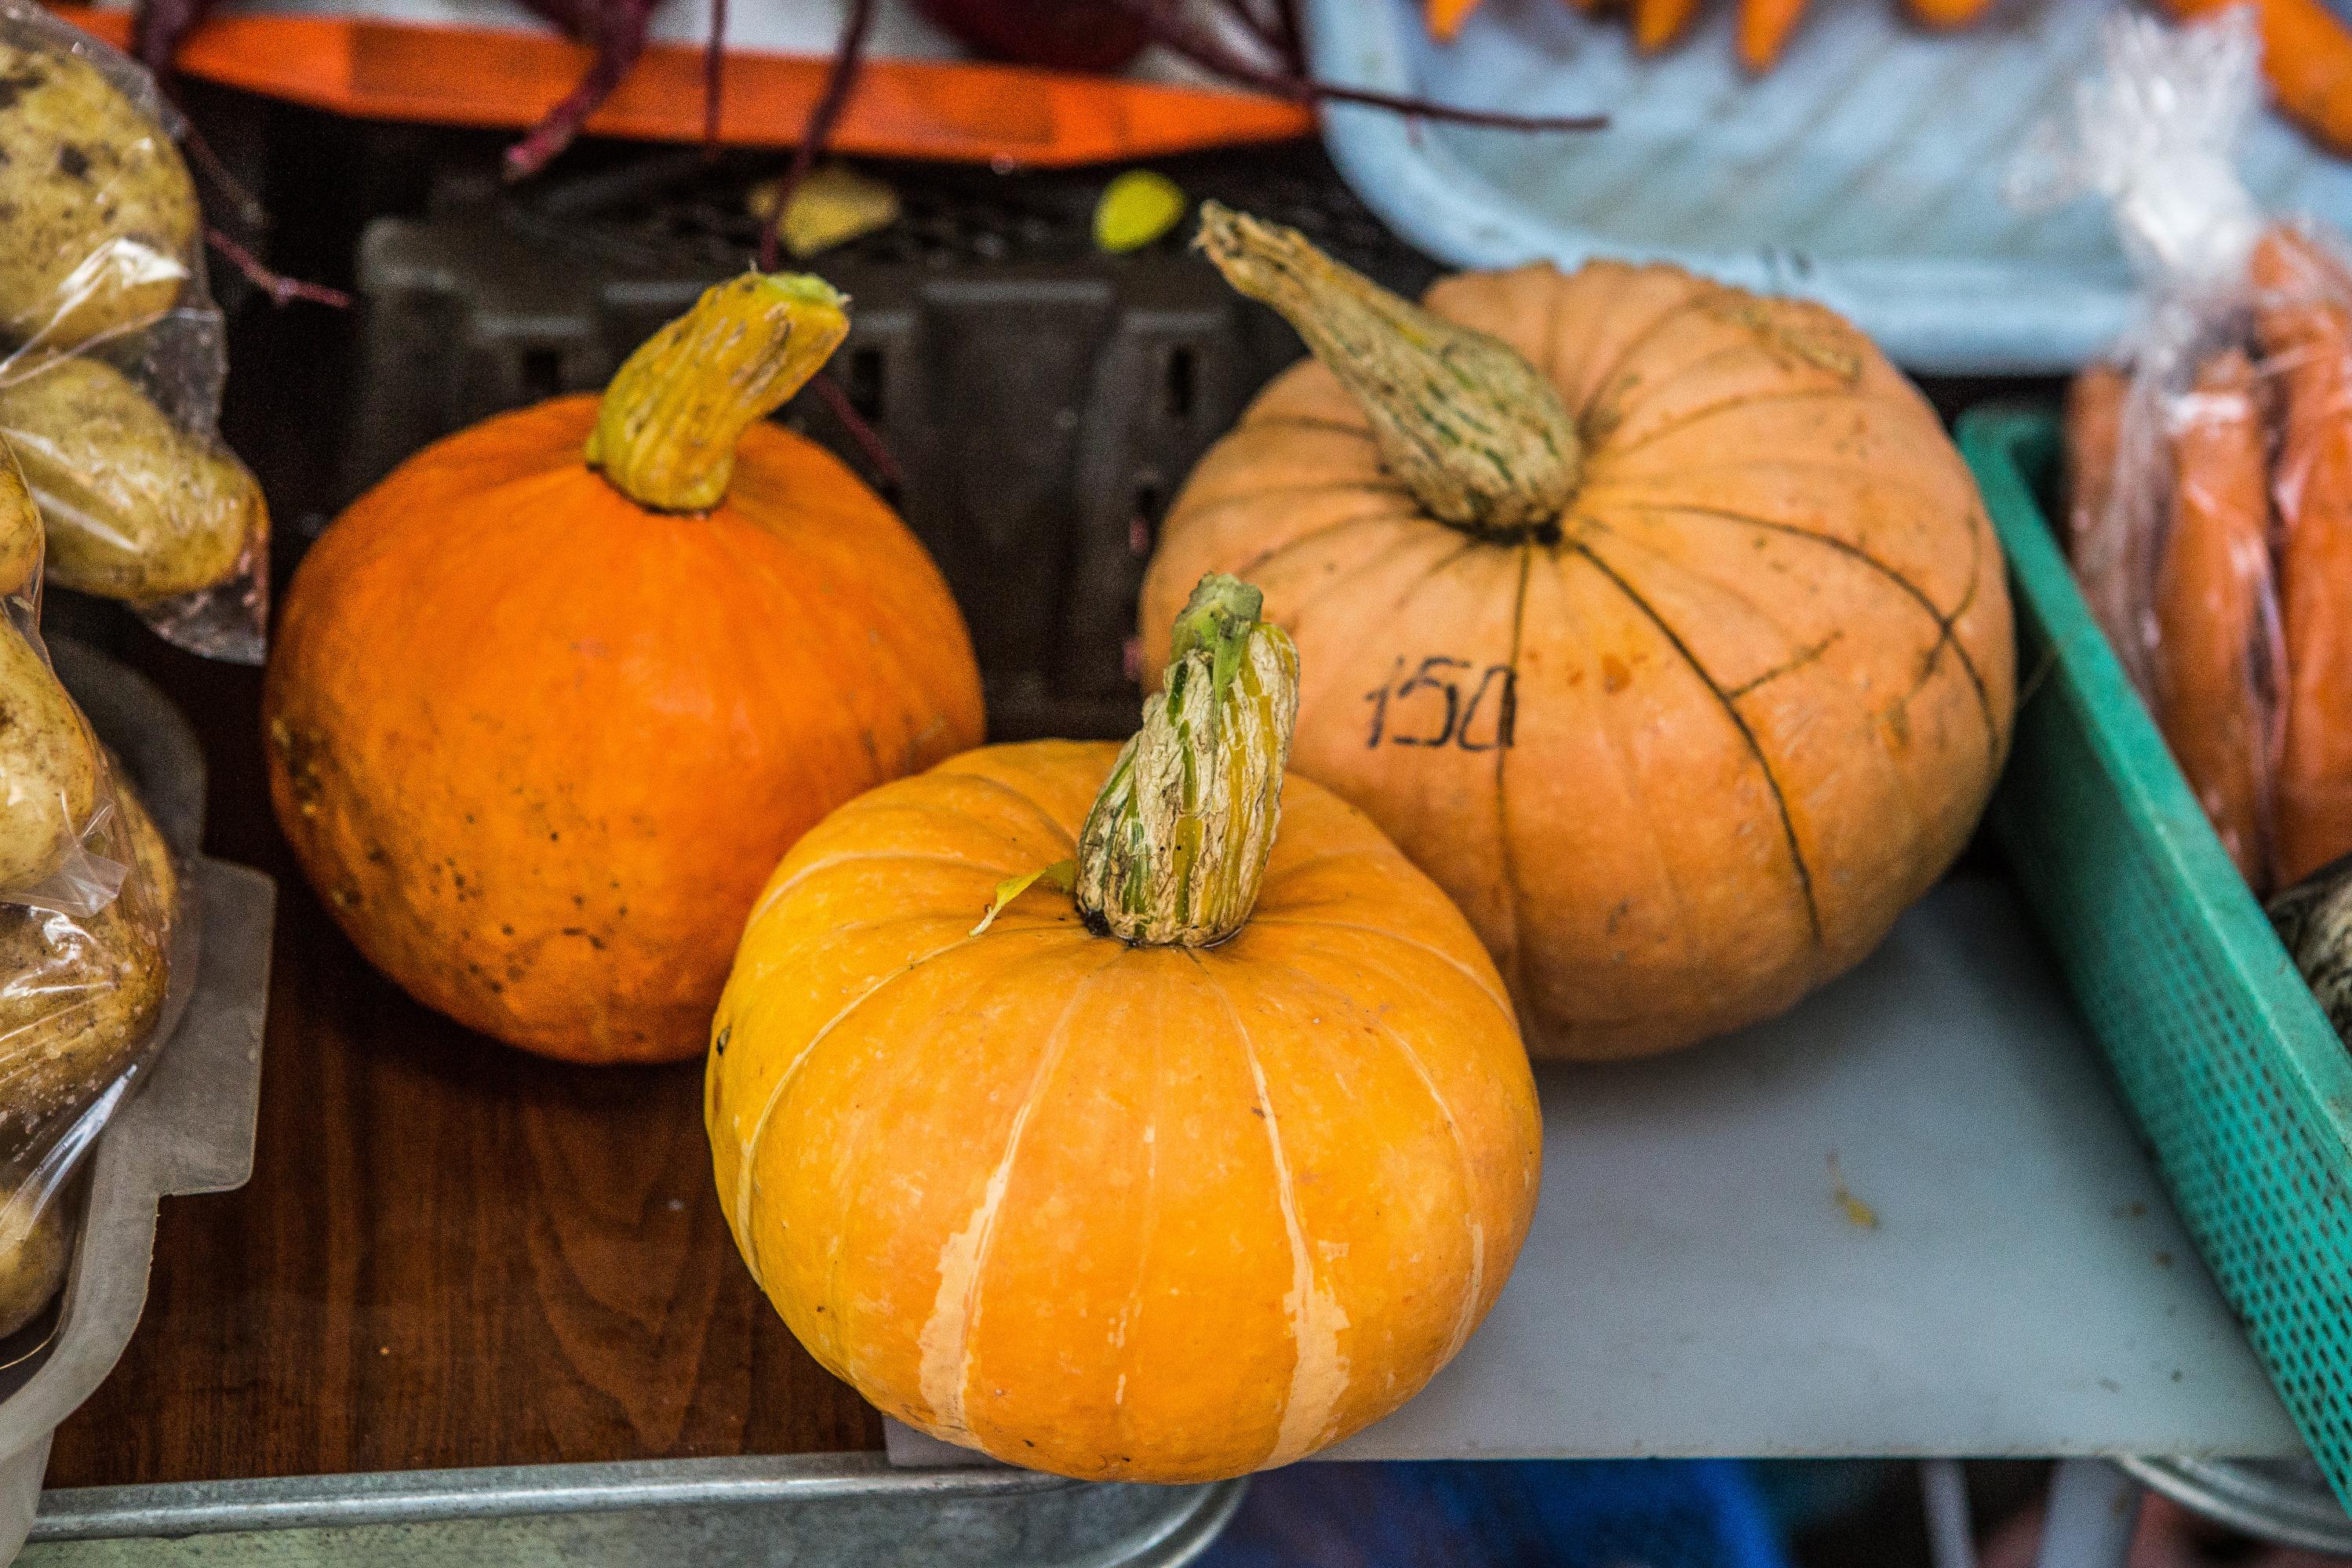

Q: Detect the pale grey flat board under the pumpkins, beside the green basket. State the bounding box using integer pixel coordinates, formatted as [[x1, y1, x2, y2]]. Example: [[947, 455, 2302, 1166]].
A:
[[889, 877, 2305, 1464]]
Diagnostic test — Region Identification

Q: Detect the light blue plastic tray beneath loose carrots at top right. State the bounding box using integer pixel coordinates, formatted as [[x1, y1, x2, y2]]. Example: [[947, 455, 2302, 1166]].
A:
[[1305, 0, 2352, 372]]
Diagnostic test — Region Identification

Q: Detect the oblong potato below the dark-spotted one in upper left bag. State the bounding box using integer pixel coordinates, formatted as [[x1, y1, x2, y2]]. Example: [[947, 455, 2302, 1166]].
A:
[[0, 360, 268, 602]]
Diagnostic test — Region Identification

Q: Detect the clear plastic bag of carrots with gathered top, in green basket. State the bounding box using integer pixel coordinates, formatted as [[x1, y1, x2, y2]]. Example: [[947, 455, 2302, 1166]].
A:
[[2013, 12, 2324, 893]]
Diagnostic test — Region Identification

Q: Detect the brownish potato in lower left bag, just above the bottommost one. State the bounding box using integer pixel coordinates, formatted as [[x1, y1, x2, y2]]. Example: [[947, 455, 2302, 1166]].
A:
[[0, 776, 179, 1129]]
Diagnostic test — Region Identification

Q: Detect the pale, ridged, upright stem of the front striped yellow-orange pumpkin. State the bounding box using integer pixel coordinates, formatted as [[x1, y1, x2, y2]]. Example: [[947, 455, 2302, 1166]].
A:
[[1077, 571, 1298, 948]]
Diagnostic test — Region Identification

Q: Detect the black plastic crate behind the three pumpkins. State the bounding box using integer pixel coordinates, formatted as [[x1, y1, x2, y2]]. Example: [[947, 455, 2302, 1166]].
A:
[[344, 151, 1435, 738]]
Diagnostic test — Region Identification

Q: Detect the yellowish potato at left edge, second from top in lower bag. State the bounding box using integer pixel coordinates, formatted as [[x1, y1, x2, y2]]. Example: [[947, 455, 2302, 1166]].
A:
[[0, 623, 99, 893]]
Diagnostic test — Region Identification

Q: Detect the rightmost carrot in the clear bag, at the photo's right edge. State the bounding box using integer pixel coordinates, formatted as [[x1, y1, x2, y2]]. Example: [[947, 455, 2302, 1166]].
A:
[[2253, 228, 2352, 886]]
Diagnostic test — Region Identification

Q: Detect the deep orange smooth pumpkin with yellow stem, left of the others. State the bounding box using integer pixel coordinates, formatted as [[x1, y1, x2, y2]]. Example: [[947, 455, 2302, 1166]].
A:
[[264, 275, 981, 1060]]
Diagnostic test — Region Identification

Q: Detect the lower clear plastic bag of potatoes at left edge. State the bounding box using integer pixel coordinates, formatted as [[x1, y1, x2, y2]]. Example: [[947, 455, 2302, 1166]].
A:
[[0, 446, 179, 1335]]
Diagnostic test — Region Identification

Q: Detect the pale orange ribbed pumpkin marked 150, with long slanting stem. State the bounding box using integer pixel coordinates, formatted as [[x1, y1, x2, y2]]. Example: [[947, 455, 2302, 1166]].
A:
[[1141, 205, 2013, 1058]]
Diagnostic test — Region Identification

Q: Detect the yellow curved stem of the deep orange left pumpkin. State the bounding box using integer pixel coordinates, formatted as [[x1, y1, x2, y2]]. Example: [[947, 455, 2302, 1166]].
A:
[[588, 273, 849, 512]]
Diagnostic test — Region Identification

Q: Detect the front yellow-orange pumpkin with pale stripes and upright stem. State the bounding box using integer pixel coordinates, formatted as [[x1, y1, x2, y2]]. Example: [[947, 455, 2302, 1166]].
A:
[[708, 578, 1541, 1481]]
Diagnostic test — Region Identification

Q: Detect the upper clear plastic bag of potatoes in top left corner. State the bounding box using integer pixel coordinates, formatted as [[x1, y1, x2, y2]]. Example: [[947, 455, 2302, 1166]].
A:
[[0, 0, 268, 663]]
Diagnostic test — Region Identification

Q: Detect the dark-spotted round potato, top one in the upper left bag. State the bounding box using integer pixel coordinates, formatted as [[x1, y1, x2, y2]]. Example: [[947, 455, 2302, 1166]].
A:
[[0, 45, 198, 348]]
